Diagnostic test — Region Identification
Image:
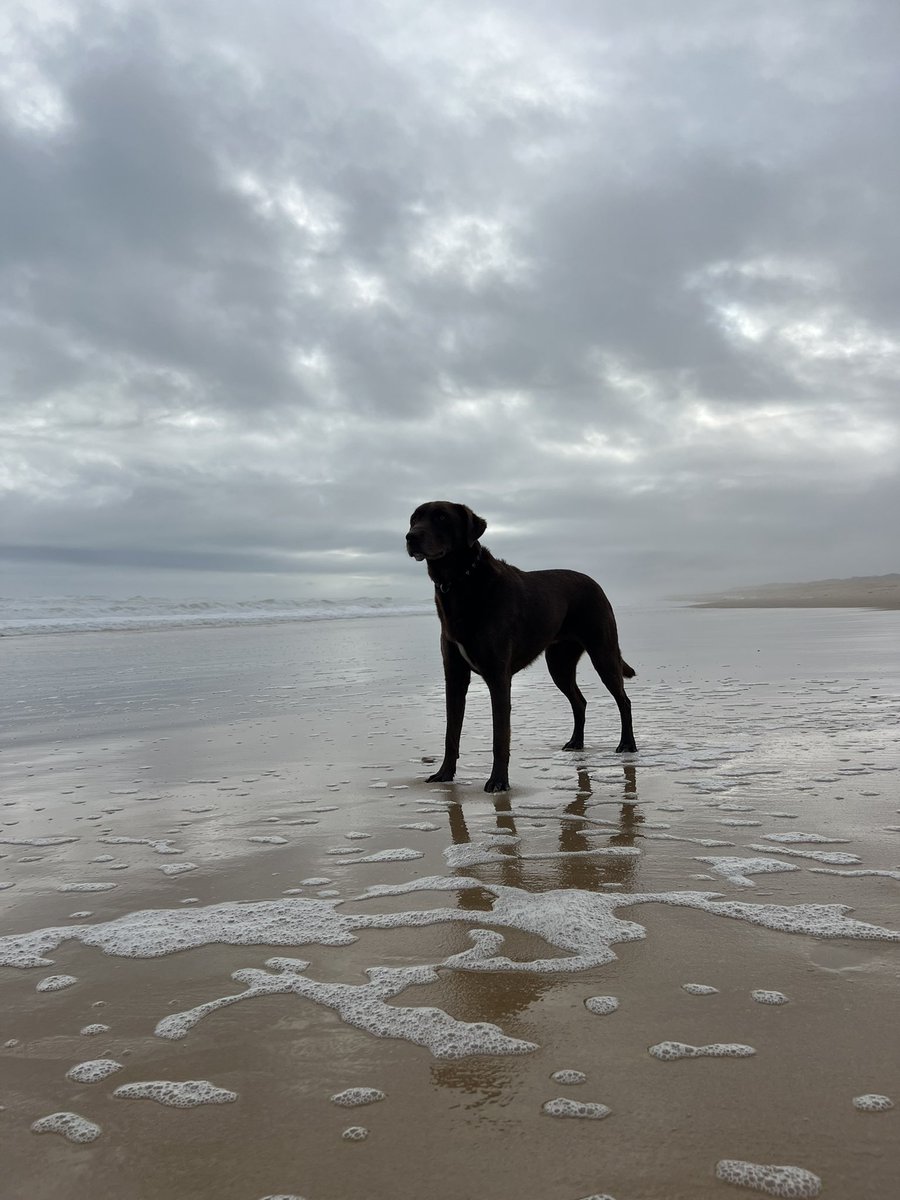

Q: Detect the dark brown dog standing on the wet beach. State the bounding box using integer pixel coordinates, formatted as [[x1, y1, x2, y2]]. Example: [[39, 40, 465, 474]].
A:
[[407, 500, 637, 792]]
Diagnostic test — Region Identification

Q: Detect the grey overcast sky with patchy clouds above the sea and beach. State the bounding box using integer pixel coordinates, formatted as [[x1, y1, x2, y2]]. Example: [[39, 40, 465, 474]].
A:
[[0, 0, 900, 599]]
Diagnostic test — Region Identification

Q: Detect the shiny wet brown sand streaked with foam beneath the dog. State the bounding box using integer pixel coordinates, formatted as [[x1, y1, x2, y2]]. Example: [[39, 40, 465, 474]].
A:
[[0, 610, 900, 1200]]
